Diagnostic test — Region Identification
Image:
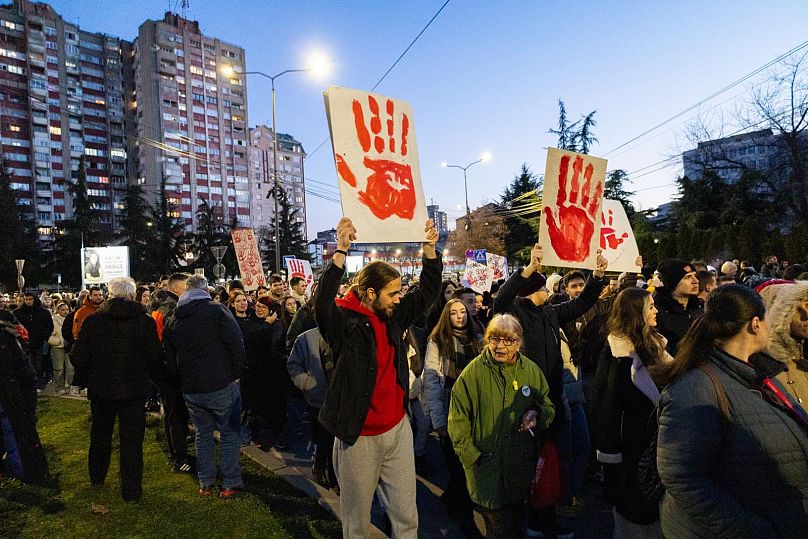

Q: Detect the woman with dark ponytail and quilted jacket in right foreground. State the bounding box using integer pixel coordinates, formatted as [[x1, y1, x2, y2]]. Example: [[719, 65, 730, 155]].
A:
[[657, 285, 808, 538]]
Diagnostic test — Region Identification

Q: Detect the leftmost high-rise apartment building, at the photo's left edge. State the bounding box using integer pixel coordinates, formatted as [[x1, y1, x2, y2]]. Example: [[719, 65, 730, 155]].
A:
[[0, 0, 128, 235]]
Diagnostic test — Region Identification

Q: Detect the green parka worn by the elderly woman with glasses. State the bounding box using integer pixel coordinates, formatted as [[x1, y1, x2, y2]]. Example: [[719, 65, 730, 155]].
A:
[[448, 348, 555, 509]]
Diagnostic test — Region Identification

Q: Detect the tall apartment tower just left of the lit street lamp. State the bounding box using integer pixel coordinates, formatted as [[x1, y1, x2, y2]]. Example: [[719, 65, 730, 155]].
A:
[[130, 12, 251, 230]]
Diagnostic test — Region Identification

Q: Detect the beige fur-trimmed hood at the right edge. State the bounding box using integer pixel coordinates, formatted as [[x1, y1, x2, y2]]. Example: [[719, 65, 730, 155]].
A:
[[764, 281, 808, 364]]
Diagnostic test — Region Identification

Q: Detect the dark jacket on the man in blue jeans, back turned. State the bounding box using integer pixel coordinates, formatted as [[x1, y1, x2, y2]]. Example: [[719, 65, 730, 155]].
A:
[[163, 291, 245, 394]]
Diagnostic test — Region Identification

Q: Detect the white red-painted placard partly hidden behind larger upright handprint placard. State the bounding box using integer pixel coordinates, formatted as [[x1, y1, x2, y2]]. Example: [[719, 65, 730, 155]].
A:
[[600, 198, 642, 273]]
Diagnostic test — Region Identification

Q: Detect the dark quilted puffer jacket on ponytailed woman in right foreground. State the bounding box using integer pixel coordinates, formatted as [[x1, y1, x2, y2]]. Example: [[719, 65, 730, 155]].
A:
[[657, 349, 808, 539]]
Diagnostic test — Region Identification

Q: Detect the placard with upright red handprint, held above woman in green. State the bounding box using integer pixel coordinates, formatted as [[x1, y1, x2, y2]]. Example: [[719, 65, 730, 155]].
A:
[[539, 148, 606, 269]]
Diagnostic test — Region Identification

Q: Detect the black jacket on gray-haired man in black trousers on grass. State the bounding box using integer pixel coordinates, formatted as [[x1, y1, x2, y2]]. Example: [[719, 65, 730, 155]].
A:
[[70, 298, 162, 400]]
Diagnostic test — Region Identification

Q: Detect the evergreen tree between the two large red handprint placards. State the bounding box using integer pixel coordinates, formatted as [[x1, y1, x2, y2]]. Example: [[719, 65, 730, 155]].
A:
[[501, 163, 542, 264]]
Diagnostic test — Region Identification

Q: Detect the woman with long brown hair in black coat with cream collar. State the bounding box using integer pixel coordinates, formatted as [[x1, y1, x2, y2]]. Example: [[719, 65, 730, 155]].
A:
[[593, 288, 673, 539]]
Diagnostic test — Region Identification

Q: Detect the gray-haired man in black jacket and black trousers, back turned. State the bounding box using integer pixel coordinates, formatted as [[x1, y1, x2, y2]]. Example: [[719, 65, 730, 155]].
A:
[[70, 277, 163, 501]]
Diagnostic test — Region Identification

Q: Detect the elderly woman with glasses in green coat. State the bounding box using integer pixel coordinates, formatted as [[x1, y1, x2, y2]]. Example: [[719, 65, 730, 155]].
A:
[[448, 314, 555, 537]]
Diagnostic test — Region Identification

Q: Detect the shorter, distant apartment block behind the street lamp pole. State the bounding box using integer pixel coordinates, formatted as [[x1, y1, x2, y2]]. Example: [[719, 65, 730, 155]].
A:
[[249, 125, 307, 237]]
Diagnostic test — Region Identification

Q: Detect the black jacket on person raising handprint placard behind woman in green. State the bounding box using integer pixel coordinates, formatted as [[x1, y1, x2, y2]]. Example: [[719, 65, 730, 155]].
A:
[[494, 272, 607, 430]]
